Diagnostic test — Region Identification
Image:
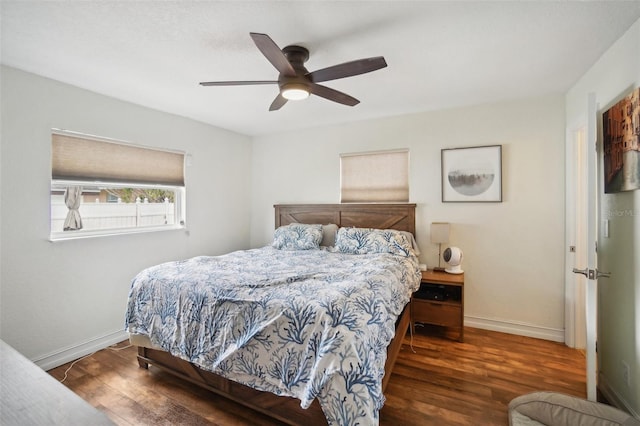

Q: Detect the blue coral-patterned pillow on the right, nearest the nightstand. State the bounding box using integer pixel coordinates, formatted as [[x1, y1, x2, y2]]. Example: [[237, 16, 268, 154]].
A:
[[336, 228, 415, 257]]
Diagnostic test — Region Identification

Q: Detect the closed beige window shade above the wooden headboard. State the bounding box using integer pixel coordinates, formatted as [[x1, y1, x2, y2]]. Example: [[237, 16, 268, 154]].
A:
[[340, 150, 409, 203]]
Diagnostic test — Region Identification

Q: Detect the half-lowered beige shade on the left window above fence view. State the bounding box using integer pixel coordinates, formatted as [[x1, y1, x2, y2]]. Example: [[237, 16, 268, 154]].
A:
[[51, 133, 184, 186]]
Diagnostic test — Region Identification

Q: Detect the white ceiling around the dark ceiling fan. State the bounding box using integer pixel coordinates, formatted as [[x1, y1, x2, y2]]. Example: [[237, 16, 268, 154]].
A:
[[0, 0, 640, 135]]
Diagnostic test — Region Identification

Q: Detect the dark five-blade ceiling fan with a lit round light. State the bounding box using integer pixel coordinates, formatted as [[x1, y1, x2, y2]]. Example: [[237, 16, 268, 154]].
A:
[[200, 33, 387, 111]]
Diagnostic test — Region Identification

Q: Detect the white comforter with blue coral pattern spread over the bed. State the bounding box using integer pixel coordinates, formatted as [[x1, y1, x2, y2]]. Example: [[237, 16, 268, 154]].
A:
[[126, 247, 420, 425]]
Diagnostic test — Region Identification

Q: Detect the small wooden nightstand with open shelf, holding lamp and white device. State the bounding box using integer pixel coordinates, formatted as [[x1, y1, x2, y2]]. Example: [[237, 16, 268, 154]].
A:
[[411, 270, 464, 342]]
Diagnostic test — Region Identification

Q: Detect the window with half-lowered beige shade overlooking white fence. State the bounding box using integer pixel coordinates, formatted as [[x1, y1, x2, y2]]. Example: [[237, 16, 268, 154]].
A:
[[50, 130, 185, 240]]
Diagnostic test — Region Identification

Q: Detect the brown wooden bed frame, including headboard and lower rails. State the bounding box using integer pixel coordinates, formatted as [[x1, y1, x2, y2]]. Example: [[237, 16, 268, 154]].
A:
[[138, 204, 416, 425]]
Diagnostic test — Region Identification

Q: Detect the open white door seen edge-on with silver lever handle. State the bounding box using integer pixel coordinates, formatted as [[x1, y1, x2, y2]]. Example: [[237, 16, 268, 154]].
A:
[[573, 94, 608, 401]]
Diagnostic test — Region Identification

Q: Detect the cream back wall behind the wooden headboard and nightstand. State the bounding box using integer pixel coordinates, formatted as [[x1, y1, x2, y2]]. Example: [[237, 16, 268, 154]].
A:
[[251, 95, 564, 341]]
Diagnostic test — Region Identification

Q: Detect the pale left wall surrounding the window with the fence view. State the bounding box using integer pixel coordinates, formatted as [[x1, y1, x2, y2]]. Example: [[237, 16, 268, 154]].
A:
[[0, 67, 251, 368]]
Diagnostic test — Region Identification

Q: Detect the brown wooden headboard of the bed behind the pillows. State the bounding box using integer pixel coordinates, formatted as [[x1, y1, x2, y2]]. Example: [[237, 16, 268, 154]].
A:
[[273, 204, 416, 235]]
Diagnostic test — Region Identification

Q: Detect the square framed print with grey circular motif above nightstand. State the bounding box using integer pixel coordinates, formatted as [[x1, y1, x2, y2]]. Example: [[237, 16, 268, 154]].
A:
[[442, 145, 502, 203]]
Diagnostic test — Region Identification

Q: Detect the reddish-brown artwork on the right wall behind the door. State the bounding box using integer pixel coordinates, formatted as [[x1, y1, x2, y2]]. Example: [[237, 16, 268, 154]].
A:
[[602, 88, 640, 193]]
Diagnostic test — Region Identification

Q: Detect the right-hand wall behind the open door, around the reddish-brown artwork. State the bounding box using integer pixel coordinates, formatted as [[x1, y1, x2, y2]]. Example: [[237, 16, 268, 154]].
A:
[[566, 20, 640, 416]]
